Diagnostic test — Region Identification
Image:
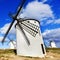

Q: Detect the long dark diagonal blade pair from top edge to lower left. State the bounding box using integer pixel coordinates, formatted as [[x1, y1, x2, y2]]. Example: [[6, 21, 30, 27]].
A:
[[2, 0, 26, 43]]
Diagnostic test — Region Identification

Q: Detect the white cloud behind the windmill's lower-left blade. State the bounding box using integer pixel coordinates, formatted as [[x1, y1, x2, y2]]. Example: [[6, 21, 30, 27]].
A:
[[0, 22, 16, 40]]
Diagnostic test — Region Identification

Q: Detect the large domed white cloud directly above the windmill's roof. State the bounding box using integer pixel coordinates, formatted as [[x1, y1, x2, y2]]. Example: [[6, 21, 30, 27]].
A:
[[19, 1, 54, 21]]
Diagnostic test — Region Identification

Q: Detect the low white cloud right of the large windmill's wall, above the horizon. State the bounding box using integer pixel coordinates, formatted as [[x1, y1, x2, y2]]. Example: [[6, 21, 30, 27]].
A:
[[42, 28, 60, 40]]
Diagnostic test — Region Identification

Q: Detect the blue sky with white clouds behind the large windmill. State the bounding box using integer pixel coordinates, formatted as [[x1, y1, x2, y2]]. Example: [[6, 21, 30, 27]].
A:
[[0, 0, 60, 48]]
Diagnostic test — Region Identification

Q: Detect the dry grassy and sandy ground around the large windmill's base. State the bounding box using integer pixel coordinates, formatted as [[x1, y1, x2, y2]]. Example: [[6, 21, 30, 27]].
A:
[[0, 48, 60, 60]]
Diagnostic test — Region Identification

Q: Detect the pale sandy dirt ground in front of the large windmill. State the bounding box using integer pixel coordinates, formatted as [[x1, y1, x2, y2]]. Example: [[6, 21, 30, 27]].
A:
[[0, 48, 60, 60]]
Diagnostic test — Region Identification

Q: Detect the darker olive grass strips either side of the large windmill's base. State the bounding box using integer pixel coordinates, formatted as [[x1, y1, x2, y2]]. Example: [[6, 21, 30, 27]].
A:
[[0, 48, 60, 55]]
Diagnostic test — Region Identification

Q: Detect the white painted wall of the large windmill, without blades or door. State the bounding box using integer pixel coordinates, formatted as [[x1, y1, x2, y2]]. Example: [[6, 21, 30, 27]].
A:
[[16, 20, 46, 57]]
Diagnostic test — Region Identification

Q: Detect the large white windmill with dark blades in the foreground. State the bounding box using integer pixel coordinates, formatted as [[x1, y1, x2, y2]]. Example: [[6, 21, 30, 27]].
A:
[[2, 0, 46, 57]]
